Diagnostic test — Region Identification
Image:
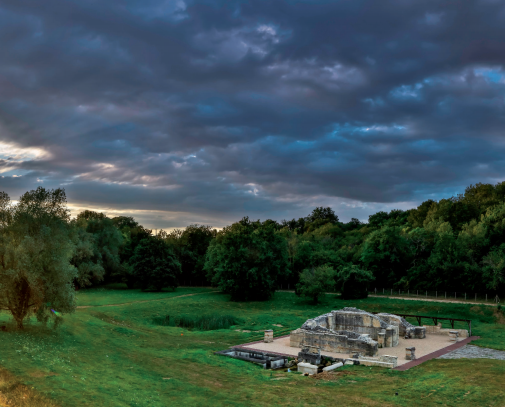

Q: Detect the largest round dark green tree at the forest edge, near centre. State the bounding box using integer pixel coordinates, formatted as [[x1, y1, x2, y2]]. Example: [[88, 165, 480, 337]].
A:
[[205, 217, 289, 300]]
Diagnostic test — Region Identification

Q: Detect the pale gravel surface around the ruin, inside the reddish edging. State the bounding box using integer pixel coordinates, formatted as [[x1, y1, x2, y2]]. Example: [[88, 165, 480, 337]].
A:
[[242, 332, 454, 365]]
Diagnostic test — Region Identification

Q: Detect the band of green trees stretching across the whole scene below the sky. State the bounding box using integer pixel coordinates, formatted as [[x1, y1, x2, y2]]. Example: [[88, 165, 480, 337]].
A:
[[0, 182, 505, 327]]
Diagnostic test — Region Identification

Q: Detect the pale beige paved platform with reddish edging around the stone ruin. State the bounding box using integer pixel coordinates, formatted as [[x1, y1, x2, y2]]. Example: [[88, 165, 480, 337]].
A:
[[234, 334, 478, 371]]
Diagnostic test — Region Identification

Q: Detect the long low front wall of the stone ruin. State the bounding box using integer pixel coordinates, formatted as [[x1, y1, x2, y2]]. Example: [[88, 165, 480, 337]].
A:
[[290, 328, 379, 356]]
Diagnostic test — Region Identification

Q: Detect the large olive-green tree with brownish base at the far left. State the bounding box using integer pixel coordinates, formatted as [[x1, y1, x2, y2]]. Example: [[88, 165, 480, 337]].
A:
[[0, 187, 76, 329]]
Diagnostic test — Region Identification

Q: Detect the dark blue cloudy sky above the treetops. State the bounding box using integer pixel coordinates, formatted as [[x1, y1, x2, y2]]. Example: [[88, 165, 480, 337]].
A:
[[0, 0, 505, 230]]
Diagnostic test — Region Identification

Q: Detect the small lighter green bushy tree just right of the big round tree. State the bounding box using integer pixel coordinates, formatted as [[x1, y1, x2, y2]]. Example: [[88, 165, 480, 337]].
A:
[[296, 265, 335, 303]]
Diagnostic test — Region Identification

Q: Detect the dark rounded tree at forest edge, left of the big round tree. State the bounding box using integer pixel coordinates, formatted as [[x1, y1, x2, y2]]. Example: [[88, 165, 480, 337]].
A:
[[129, 236, 181, 291]]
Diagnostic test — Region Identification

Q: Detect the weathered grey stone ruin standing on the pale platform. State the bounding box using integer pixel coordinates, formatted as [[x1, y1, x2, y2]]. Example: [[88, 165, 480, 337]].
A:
[[290, 307, 426, 357]]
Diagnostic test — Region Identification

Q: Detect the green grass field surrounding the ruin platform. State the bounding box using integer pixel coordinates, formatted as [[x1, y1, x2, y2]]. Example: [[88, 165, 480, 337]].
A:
[[0, 285, 505, 406]]
